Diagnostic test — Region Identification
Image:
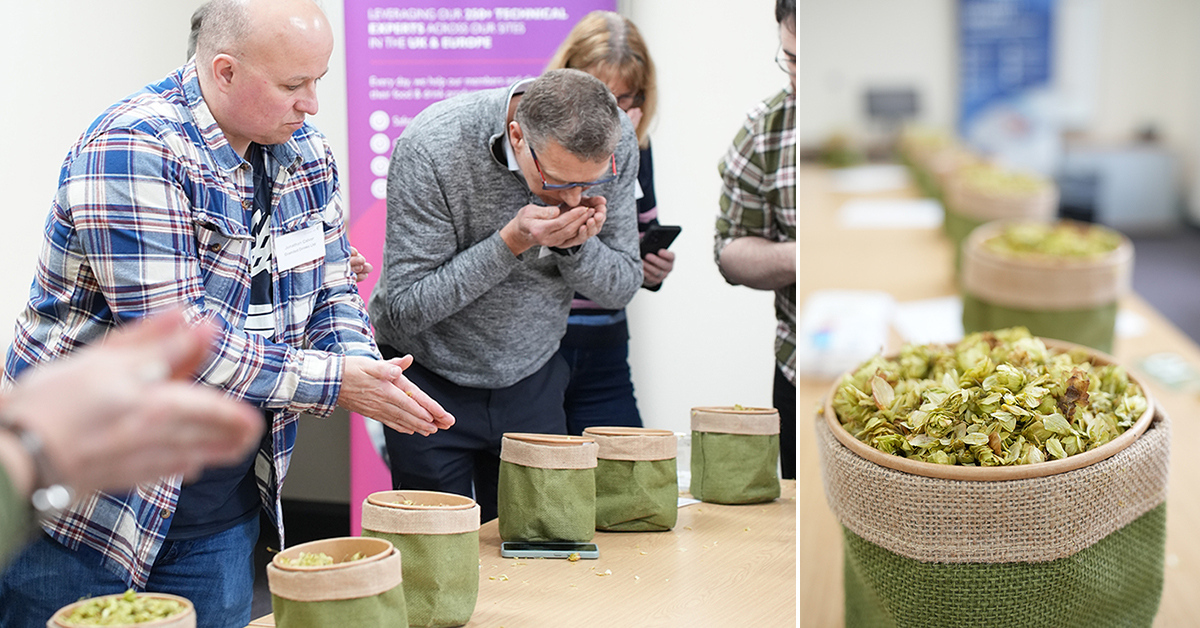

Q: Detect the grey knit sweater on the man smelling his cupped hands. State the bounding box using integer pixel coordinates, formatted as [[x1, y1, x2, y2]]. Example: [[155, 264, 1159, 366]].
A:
[[368, 83, 642, 388]]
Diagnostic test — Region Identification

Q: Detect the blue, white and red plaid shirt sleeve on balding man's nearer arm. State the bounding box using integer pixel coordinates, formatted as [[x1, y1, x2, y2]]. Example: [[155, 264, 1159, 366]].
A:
[[59, 130, 343, 414]]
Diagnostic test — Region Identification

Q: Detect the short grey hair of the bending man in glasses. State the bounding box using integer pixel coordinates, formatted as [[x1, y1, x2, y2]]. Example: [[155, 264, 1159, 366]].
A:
[[514, 70, 620, 162]]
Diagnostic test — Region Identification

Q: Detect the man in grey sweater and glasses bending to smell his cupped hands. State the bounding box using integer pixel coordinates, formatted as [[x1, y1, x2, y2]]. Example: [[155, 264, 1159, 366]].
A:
[[370, 70, 642, 520]]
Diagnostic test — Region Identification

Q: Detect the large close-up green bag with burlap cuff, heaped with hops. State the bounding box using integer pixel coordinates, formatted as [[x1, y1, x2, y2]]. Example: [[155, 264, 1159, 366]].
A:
[[816, 329, 1170, 628]]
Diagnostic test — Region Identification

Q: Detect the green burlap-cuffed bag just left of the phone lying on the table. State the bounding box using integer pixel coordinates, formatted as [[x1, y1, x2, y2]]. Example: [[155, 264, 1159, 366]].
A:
[[362, 490, 480, 628]]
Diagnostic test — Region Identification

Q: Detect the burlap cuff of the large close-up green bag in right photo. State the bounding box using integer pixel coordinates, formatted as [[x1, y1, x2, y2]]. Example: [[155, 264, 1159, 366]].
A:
[[816, 407, 1170, 563]]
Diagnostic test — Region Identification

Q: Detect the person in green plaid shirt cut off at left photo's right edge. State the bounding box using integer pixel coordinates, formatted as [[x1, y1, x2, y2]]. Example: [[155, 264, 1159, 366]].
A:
[[715, 0, 796, 479]]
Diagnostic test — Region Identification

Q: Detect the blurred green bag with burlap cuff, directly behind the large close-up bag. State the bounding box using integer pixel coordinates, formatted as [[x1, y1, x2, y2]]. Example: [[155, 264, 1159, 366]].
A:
[[962, 221, 1133, 353]]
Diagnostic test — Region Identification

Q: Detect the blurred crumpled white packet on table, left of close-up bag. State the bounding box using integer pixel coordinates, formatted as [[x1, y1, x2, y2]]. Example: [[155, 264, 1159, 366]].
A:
[[796, 291, 895, 378]]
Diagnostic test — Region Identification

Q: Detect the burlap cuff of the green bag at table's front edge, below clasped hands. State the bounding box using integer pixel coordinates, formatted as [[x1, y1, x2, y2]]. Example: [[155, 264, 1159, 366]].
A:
[[266, 549, 403, 602]]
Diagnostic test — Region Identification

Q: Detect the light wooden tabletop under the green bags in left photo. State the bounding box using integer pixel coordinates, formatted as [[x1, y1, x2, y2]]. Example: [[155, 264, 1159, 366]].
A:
[[251, 480, 796, 628]]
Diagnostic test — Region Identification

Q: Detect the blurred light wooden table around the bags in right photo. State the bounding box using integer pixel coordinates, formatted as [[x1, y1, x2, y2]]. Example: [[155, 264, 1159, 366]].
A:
[[797, 167, 1200, 628]]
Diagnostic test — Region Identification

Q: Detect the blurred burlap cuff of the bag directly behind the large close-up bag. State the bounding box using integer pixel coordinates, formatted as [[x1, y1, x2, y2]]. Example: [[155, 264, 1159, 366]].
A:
[[962, 221, 1133, 310]]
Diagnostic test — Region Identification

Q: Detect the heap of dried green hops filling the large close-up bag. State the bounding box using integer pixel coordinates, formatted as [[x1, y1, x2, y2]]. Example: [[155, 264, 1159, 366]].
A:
[[833, 328, 1147, 466]]
